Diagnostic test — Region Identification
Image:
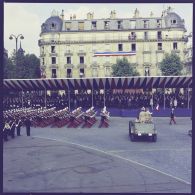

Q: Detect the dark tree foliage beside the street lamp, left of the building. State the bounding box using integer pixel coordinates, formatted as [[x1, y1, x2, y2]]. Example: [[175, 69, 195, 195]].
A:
[[4, 53, 40, 79]]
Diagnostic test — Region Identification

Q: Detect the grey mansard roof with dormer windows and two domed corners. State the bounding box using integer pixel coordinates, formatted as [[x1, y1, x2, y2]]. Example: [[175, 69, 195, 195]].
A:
[[41, 12, 186, 33]]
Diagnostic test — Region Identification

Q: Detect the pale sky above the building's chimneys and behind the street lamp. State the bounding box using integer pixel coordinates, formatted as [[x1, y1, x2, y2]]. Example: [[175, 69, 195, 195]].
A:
[[4, 3, 193, 57]]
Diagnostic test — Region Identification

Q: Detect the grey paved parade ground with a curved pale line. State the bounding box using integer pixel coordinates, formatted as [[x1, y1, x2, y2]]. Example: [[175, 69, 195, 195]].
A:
[[3, 117, 192, 193]]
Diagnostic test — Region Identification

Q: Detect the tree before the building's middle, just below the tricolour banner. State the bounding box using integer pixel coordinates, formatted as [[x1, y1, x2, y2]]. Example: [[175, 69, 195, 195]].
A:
[[112, 57, 139, 77]]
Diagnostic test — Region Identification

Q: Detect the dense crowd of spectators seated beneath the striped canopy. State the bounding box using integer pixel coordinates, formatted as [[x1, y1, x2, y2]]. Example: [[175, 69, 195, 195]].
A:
[[3, 91, 192, 110]]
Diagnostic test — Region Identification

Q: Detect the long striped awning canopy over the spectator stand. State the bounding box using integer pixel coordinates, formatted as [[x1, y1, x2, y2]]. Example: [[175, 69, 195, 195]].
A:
[[4, 76, 192, 91]]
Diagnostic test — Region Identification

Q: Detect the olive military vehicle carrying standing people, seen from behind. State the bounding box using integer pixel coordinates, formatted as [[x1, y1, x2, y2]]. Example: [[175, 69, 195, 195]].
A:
[[129, 121, 157, 142]]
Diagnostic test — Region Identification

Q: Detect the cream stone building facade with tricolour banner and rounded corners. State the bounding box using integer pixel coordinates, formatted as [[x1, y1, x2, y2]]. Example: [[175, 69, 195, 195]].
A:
[[38, 8, 188, 78]]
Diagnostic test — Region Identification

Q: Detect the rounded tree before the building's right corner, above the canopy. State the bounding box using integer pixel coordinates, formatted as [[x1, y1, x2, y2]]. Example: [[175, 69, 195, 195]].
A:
[[160, 53, 183, 76]]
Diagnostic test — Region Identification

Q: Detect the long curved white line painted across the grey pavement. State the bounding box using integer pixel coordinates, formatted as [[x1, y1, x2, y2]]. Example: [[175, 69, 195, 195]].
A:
[[32, 136, 191, 185]]
